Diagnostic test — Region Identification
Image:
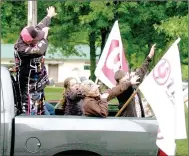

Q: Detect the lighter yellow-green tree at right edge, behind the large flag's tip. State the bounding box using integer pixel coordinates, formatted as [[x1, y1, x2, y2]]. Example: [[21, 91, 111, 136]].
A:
[[154, 2, 188, 80]]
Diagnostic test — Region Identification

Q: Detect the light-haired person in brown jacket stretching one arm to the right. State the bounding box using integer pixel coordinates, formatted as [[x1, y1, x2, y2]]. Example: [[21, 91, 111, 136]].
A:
[[82, 76, 138, 117]]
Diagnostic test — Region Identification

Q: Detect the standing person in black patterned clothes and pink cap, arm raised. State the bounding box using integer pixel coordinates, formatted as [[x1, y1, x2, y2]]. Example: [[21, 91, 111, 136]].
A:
[[14, 6, 57, 115]]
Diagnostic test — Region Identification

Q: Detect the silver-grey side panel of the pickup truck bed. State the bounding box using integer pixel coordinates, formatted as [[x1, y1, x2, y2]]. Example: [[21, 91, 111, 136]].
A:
[[15, 116, 158, 156]]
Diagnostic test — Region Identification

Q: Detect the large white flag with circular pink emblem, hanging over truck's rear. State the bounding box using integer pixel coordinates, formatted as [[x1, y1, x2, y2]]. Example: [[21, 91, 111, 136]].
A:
[[139, 38, 186, 155]]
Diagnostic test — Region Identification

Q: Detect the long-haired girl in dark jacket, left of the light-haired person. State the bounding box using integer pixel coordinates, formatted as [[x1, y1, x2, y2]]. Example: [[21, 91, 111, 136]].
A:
[[59, 77, 84, 116]]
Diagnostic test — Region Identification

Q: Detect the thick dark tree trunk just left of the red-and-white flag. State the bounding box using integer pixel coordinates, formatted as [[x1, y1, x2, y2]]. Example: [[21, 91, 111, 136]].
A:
[[89, 32, 96, 81]]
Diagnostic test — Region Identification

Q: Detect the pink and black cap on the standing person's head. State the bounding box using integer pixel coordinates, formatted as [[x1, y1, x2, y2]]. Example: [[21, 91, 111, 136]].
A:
[[20, 26, 45, 42]]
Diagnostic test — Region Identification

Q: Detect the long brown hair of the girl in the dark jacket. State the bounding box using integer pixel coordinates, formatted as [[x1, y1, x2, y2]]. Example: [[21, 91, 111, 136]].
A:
[[60, 77, 75, 110]]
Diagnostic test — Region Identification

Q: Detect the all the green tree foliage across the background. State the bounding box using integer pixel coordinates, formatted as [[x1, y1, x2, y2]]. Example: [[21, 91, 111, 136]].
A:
[[1, 0, 188, 80]]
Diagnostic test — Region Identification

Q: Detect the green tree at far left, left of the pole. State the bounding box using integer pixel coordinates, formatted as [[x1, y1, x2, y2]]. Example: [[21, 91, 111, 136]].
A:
[[1, 1, 27, 43]]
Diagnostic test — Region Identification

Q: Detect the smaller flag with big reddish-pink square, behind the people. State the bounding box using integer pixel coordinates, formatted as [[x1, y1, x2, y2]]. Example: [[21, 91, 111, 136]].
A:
[[95, 21, 128, 88]]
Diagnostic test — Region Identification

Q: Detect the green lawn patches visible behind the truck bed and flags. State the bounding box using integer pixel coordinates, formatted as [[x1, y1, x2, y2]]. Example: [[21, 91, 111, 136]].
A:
[[45, 87, 188, 156]]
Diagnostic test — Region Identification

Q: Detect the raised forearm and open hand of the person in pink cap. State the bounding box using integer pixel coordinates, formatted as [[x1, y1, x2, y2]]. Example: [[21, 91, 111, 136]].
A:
[[36, 6, 57, 30]]
